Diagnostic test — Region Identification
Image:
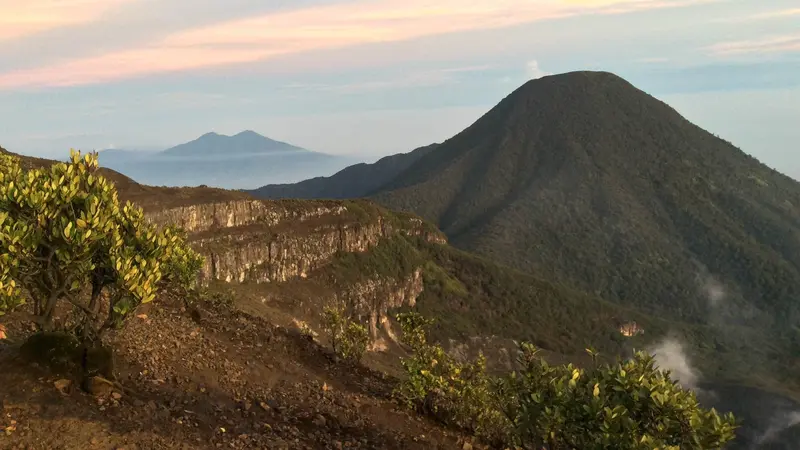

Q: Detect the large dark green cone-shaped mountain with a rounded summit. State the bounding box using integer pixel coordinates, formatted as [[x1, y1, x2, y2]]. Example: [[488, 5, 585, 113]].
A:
[[254, 72, 800, 334]]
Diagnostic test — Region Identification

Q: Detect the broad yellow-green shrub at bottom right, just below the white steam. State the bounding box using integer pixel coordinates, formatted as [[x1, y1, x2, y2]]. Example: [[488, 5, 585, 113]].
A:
[[497, 344, 735, 450]]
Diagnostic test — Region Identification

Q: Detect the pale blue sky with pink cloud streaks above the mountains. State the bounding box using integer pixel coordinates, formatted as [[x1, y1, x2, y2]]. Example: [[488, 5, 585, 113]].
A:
[[0, 0, 800, 179]]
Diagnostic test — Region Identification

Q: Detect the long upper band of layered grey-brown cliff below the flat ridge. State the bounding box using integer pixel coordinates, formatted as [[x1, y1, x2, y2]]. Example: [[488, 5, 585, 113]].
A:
[[148, 200, 446, 283]]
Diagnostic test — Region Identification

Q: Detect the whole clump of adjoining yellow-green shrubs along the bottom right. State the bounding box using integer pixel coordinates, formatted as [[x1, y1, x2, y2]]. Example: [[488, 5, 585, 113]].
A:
[[396, 313, 736, 450]]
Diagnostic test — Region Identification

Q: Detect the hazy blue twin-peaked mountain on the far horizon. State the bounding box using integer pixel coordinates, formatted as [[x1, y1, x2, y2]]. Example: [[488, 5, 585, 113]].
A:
[[95, 130, 360, 189]]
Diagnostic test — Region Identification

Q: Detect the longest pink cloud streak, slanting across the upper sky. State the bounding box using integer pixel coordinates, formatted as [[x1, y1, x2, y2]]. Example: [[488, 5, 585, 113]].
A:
[[0, 0, 714, 89]]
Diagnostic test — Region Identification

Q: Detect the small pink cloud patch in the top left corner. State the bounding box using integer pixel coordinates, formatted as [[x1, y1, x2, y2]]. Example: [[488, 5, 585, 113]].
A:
[[0, 0, 130, 42]]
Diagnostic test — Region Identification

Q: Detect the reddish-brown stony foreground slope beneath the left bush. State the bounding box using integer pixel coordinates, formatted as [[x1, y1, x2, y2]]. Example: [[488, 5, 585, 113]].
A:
[[0, 301, 479, 450]]
